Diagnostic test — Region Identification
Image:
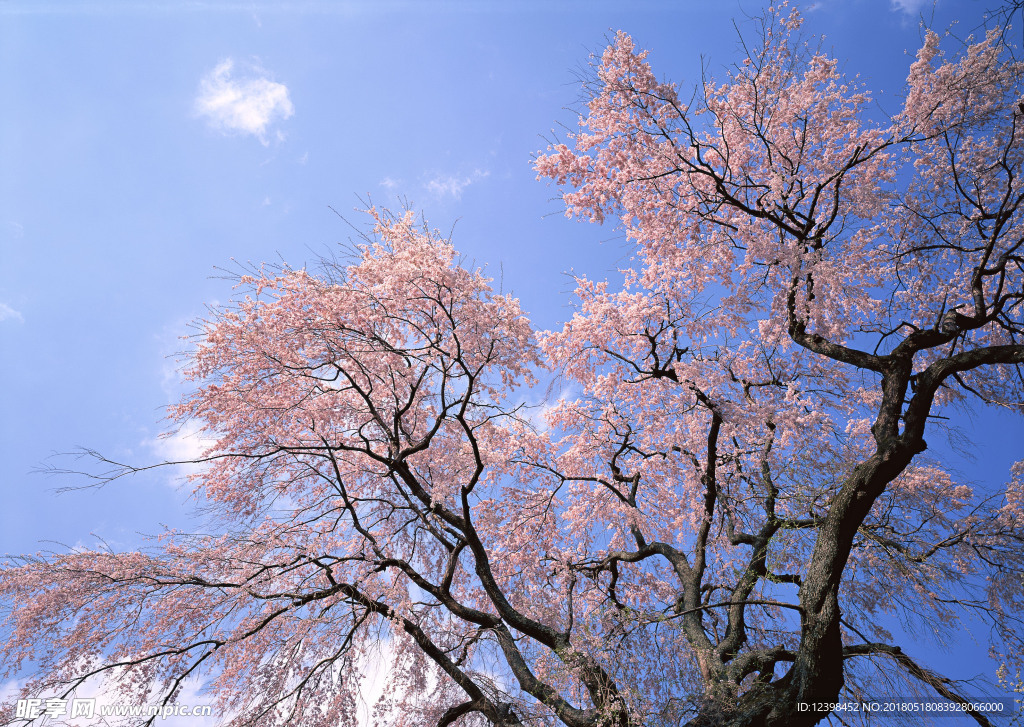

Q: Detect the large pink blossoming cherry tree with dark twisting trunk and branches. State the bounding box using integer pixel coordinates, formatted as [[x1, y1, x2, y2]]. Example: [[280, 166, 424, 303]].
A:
[[0, 8, 1024, 727]]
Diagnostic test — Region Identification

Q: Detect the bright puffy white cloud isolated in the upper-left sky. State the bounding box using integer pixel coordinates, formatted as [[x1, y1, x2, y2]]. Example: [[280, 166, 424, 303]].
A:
[[196, 58, 295, 146]]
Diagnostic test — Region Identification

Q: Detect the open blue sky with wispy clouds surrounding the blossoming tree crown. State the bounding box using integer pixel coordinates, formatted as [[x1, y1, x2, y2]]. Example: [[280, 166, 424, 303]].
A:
[[0, 0, 1024, 724]]
